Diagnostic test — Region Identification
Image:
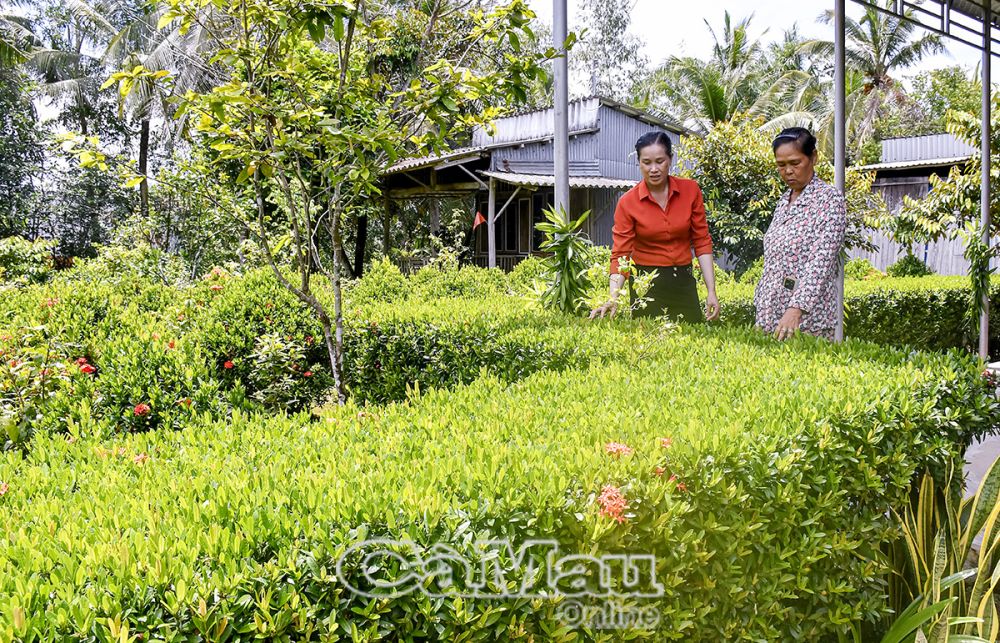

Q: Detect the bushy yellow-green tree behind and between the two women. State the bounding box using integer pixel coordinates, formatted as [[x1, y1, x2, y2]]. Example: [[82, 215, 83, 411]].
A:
[[678, 115, 887, 273]]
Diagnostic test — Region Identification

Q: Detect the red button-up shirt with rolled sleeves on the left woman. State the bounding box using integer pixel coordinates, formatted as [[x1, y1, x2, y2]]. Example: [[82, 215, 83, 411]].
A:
[[611, 176, 712, 274]]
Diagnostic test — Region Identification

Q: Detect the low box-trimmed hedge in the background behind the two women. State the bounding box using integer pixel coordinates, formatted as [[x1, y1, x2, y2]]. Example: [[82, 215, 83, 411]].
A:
[[719, 276, 1000, 350]]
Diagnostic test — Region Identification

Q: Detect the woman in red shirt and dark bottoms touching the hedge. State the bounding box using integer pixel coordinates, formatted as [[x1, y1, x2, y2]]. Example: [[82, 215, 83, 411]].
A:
[[590, 132, 719, 322]]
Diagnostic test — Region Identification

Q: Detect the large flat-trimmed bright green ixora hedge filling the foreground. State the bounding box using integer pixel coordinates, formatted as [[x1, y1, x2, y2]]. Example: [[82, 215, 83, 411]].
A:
[[0, 323, 997, 642]]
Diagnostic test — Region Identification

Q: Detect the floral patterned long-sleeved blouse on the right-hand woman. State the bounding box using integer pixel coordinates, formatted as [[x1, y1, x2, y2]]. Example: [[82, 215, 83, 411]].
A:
[[754, 174, 847, 340]]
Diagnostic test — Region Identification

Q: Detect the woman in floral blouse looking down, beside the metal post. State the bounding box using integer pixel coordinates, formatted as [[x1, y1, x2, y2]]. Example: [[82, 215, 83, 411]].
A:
[[754, 127, 847, 340]]
